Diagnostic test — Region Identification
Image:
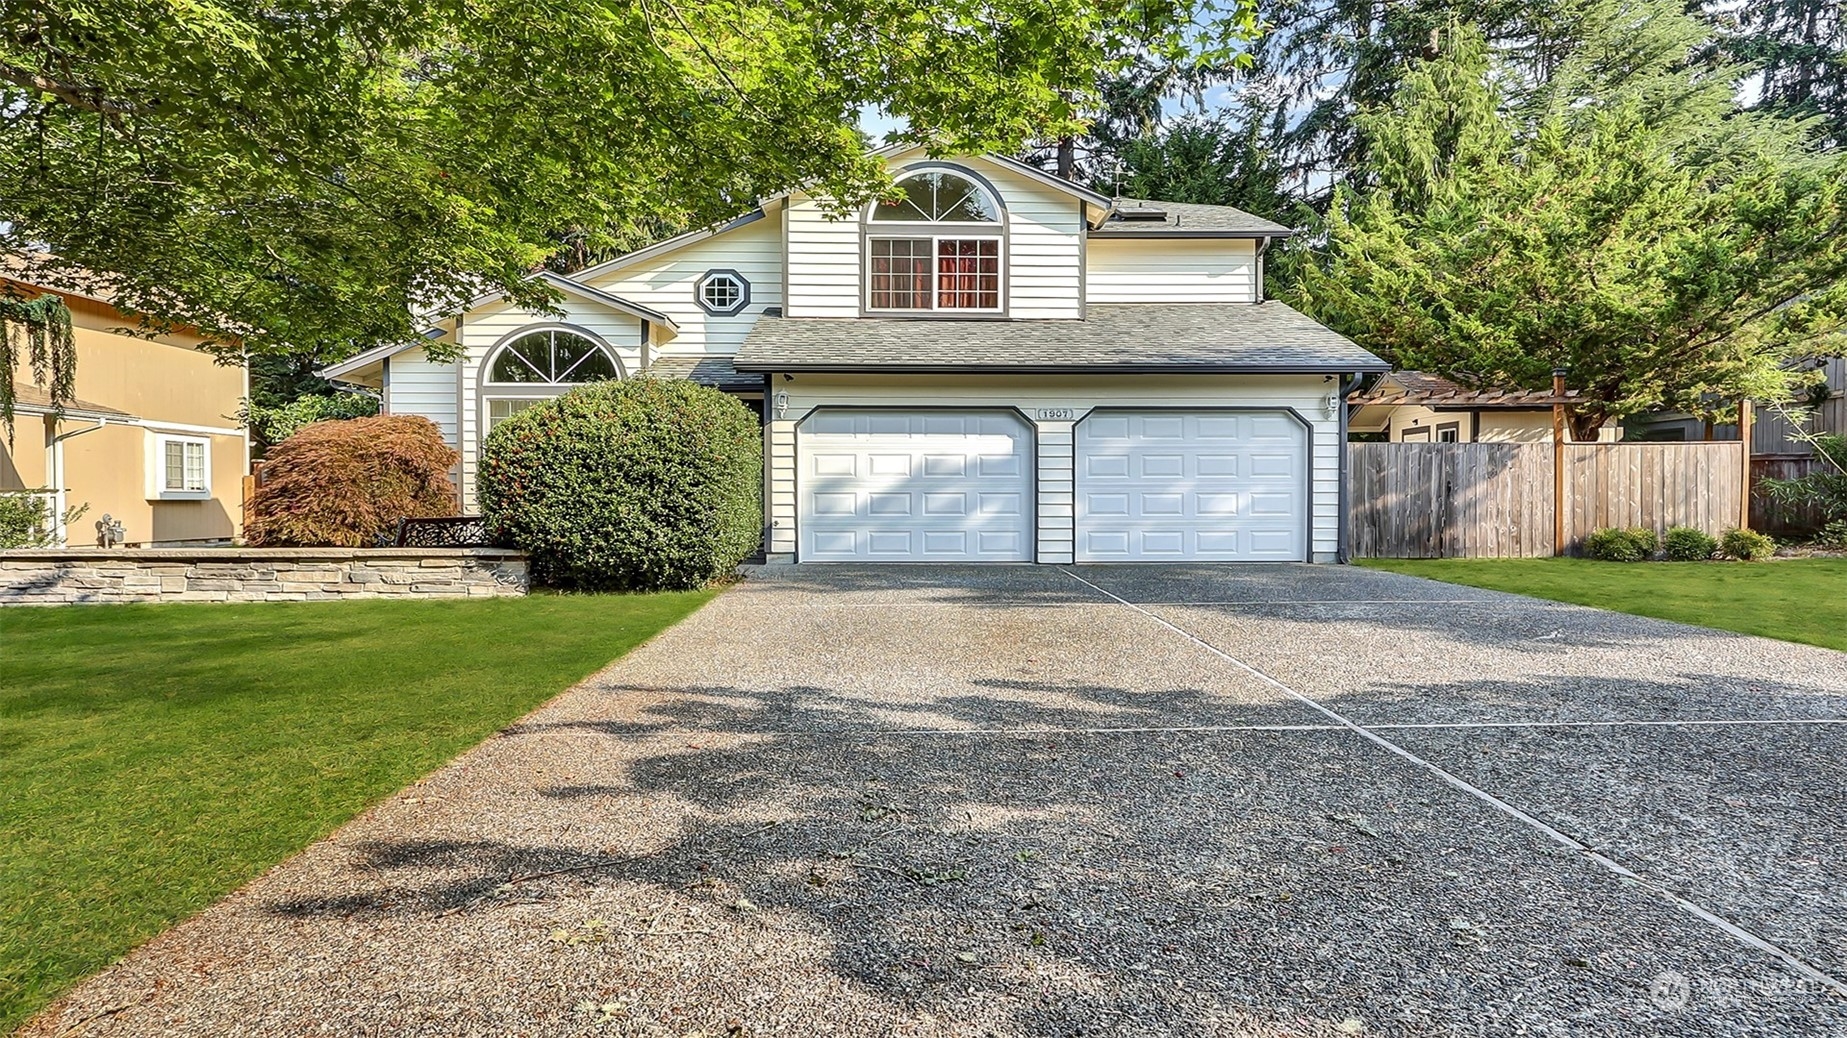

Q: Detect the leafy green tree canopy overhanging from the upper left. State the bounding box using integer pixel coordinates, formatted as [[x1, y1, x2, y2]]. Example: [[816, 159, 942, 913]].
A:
[[0, 0, 1243, 380]]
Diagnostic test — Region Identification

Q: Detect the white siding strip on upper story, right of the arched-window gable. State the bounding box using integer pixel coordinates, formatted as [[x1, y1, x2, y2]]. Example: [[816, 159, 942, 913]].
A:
[[1086, 238, 1258, 303]]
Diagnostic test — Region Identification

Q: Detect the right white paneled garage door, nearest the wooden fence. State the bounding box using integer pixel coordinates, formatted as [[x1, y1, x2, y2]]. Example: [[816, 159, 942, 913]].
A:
[[1075, 410, 1308, 561]]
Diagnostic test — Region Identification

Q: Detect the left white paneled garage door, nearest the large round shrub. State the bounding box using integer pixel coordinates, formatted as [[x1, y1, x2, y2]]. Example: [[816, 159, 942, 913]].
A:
[[796, 408, 1032, 561]]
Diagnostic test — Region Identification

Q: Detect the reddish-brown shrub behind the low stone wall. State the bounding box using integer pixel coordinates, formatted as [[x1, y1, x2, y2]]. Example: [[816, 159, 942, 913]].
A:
[[244, 416, 456, 549]]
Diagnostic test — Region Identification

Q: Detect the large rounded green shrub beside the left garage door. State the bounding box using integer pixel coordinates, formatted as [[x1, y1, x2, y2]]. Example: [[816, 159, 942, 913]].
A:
[[477, 379, 763, 591]]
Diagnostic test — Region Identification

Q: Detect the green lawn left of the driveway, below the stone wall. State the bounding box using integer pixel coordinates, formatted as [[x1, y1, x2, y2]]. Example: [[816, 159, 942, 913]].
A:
[[0, 593, 709, 1034]]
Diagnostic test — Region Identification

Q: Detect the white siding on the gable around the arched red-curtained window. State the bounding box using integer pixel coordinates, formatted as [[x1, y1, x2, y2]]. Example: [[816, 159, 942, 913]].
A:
[[787, 157, 1084, 318]]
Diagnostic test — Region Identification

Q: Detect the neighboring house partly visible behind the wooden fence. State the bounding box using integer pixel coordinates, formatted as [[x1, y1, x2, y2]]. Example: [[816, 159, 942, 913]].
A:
[[1346, 371, 1622, 443]]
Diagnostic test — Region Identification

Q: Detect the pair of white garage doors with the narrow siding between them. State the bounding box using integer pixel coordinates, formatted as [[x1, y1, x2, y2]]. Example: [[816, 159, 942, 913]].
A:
[[794, 406, 1311, 561]]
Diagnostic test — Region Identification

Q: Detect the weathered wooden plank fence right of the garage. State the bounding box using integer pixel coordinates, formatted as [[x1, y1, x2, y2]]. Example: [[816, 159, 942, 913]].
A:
[[1348, 440, 1745, 558]]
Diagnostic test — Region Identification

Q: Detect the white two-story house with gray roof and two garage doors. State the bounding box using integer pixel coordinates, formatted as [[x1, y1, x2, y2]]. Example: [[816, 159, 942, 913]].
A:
[[323, 148, 1385, 563]]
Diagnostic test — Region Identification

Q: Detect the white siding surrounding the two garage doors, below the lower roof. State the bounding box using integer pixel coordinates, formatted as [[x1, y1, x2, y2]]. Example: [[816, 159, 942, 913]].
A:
[[767, 375, 1341, 563]]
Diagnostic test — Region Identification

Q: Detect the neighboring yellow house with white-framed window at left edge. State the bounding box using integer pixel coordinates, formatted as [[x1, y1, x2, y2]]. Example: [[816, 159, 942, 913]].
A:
[[0, 279, 249, 547]]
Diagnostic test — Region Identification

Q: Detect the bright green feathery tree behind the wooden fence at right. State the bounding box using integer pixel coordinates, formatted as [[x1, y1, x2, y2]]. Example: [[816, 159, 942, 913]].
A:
[[1293, 14, 1847, 438]]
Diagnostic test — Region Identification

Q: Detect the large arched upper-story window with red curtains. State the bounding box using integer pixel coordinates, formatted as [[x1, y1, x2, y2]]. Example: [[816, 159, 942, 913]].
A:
[[866, 170, 1001, 312]]
